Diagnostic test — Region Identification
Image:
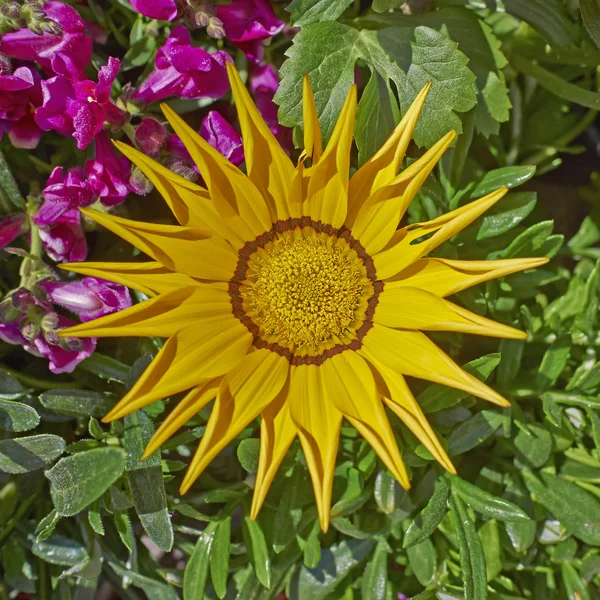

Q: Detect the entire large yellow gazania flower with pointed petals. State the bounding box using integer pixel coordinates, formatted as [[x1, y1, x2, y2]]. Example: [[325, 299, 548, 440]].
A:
[[63, 64, 546, 531]]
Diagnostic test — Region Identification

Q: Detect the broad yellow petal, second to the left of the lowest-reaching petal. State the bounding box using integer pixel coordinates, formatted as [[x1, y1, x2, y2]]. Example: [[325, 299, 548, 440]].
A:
[[179, 350, 289, 494]]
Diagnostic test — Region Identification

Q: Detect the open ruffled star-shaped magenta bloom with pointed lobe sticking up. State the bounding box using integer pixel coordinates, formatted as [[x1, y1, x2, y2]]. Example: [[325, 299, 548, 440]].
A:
[[35, 57, 127, 150]]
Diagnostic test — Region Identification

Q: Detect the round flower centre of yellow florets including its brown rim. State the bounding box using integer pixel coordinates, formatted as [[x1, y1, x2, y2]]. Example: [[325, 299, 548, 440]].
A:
[[229, 218, 379, 364]]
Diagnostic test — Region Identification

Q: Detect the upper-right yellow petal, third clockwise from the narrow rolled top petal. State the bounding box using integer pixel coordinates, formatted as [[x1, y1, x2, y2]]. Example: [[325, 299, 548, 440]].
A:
[[346, 131, 456, 254]]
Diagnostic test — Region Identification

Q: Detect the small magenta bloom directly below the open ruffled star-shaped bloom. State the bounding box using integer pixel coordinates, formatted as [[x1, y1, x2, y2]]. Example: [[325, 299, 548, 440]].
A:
[[85, 131, 131, 206]]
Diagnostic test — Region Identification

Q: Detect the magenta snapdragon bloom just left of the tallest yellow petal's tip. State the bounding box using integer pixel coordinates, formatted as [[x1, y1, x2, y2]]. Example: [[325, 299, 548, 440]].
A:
[[133, 25, 231, 104]]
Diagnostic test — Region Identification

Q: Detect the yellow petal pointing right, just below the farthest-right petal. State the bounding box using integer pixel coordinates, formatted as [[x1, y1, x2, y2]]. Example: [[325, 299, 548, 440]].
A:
[[373, 284, 527, 340]]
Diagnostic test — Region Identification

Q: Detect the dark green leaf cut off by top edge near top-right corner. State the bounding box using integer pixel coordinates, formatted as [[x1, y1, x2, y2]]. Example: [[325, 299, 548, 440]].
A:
[[504, 0, 576, 46]]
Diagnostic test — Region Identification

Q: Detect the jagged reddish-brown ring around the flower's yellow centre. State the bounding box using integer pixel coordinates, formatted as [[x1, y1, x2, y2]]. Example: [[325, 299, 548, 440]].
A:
[[229, 217, 383, 366]]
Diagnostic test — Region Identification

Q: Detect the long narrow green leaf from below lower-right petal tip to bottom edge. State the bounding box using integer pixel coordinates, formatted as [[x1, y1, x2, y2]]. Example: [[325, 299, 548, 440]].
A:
[[450, 494, 487, 600]]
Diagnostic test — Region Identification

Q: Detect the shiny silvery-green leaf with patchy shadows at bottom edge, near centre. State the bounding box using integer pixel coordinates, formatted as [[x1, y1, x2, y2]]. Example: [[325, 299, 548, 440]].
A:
[[289, 539, 375, 600]]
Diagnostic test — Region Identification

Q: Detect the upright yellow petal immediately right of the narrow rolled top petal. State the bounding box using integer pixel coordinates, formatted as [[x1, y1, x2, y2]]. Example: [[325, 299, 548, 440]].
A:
[[303, 85, 356, 227]]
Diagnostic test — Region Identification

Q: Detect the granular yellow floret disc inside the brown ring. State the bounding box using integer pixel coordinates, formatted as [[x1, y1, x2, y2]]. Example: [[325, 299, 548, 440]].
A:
[[240, 228, 372, 352]]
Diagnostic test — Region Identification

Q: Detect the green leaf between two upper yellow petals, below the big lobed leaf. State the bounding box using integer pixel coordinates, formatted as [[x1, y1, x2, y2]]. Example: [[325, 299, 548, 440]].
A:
[[354, 71, 400, 165]]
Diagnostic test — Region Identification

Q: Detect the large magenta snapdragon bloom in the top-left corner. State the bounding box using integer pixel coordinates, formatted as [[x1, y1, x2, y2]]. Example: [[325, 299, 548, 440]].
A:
[[0, 1, 92, 79]]
